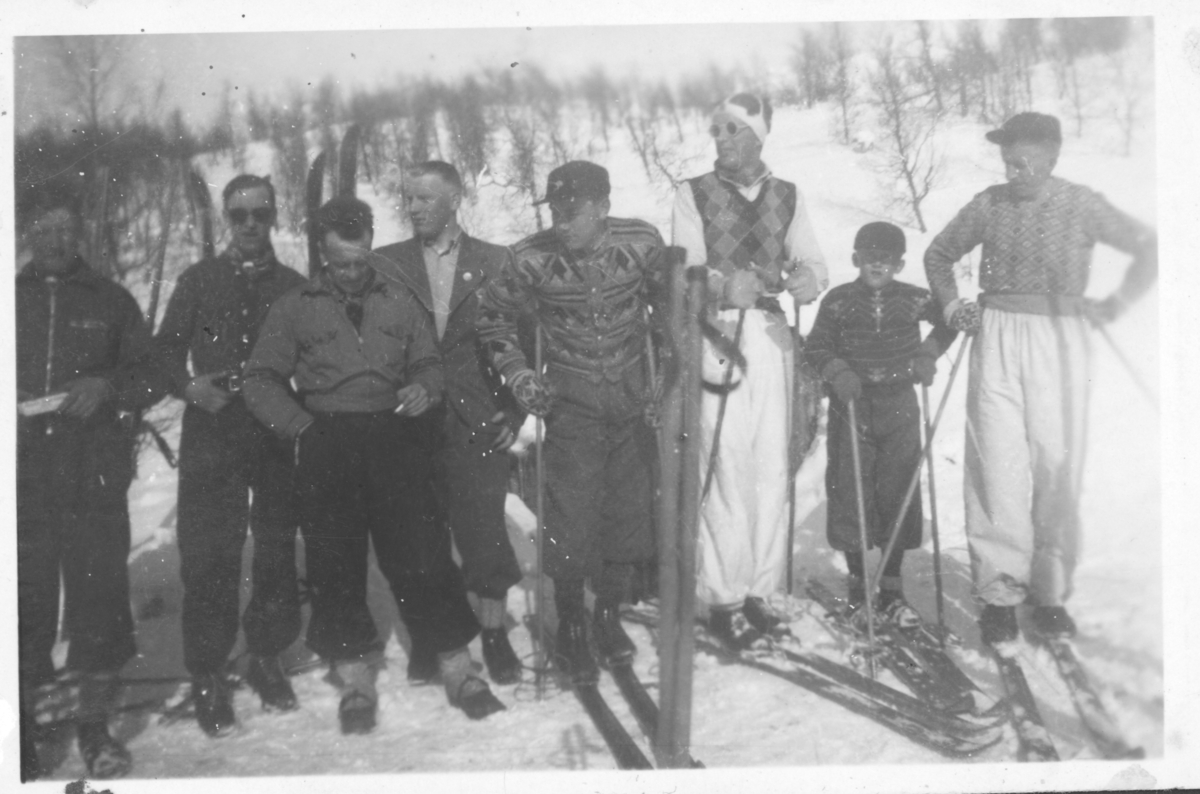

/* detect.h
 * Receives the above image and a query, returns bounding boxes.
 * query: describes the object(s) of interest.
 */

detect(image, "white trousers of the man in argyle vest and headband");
[696,309,793,607]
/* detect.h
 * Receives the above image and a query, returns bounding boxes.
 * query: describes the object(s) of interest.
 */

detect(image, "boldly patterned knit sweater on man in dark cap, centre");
[476,217,667,383]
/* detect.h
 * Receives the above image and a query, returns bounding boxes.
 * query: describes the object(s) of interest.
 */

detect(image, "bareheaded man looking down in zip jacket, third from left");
[245,197,504,733]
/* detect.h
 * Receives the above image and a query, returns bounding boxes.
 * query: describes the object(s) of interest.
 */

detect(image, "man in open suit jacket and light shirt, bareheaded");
[376,161,523,684]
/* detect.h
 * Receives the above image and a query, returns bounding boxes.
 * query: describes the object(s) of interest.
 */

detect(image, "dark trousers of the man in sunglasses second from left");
[178,399,300,675]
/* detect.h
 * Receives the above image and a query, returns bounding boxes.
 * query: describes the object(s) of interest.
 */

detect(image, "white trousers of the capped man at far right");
[964,308,1090,606]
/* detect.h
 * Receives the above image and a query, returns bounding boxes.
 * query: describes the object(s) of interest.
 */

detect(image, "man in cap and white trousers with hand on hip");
[925,113,1158,644]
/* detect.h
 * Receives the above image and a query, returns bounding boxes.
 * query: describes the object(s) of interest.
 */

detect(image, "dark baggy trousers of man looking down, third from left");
[296,411,479,661]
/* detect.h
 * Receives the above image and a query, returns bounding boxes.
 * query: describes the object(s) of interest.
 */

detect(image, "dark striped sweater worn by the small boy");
[804,278,955,387]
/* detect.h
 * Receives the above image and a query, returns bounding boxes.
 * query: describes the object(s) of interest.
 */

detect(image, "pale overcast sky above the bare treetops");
[16,24,835,126]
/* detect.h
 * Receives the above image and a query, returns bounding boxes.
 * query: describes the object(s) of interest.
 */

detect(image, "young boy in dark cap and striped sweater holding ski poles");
[805,222,955,622]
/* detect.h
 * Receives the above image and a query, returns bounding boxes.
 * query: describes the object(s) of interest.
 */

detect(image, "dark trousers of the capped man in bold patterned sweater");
[544,366,658,595]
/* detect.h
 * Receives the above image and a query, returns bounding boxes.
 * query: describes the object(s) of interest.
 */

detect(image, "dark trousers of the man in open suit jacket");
[430,404,521,598]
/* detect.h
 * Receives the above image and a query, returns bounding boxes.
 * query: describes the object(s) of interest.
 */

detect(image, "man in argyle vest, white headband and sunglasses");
[672,94,828,649]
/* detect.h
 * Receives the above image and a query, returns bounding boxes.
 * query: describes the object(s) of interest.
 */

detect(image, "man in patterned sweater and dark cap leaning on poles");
[476,161,667,684]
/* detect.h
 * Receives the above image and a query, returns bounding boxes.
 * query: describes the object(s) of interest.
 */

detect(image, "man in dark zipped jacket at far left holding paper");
[16,198,166,780]
